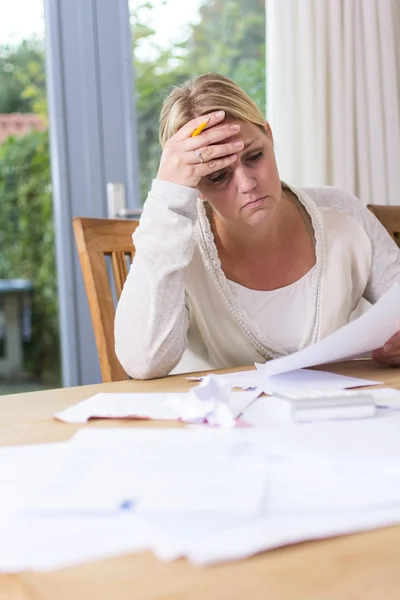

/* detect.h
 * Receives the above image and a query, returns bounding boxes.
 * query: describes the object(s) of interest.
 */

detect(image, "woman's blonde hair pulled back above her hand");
[160,73,264,148]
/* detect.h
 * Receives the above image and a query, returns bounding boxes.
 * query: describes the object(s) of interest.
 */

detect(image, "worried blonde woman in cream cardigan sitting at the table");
[115,73,400,379]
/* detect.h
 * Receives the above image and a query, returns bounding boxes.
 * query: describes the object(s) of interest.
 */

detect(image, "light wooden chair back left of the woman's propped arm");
[73,217,139,382]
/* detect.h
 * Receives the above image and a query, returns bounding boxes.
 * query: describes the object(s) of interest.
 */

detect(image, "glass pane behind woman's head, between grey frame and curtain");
[129,0,266,202]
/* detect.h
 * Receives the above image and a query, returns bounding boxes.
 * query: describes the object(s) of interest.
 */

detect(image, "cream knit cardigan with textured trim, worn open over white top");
[115,180,400,379]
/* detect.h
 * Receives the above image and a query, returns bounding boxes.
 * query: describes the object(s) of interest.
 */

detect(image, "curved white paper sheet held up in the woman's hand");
[256,283,400,375]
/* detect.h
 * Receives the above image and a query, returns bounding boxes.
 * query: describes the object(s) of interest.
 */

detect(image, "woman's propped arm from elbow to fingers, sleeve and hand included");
[115,111,244,379]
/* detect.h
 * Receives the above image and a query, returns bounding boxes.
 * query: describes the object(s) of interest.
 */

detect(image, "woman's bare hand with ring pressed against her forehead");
[157,111,243,188]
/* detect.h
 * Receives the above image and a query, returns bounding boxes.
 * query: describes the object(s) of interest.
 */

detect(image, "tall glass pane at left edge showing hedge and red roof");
[0,0,60,394]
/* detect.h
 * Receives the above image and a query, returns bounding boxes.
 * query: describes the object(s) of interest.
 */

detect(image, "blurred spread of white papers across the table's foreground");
[0,418,400,572]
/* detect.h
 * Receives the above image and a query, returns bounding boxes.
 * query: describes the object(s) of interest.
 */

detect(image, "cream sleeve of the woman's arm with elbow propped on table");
[115,179,198,379]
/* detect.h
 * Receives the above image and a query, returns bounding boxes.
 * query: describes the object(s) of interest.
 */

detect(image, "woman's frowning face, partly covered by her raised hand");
[198,121,281,225]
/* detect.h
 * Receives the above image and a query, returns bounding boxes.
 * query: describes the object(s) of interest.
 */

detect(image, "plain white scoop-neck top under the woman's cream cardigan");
[228,267,315,354]
